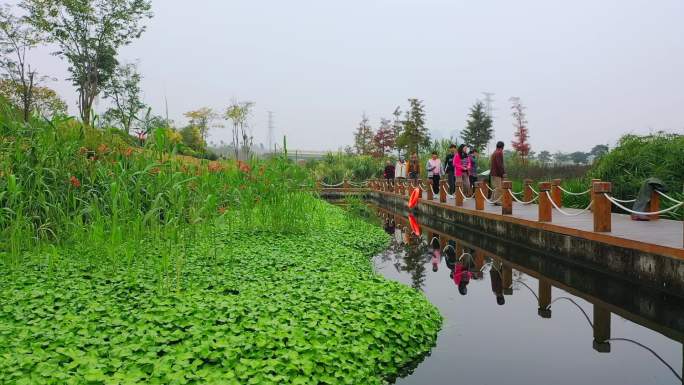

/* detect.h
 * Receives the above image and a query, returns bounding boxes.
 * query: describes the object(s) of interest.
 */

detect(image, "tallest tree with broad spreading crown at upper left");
[22,0,152,125]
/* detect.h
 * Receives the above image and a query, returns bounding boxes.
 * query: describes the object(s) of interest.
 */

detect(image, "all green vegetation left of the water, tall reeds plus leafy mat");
[0,100,441,384]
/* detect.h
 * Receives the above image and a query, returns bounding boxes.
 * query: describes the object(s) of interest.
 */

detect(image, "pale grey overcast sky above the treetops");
[25,0,684,152]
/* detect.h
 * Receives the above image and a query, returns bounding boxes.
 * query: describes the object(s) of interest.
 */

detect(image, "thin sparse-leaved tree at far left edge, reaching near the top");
[0,5,42,122]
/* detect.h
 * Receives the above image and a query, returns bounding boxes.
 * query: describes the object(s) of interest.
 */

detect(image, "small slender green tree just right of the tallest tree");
[104,64,145,133]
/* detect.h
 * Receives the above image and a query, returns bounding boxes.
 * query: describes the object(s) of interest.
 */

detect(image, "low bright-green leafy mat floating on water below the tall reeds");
[0,208,441,384]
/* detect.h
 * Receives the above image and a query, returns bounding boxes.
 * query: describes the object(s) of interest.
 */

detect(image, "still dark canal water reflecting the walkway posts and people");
[374,209,684,385]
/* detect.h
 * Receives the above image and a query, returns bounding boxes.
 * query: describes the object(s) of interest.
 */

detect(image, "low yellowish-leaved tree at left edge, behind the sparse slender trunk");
[0,79,67,118]
